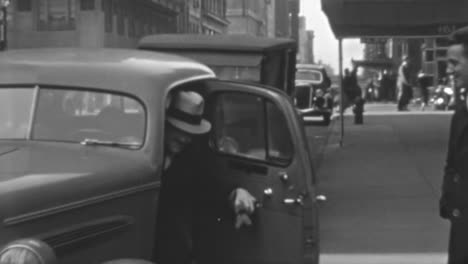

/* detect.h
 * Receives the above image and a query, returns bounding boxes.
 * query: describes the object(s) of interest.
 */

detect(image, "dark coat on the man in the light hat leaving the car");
[155,143,236,264]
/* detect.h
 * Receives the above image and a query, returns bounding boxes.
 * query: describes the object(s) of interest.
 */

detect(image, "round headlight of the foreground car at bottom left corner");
[0,239,57,264]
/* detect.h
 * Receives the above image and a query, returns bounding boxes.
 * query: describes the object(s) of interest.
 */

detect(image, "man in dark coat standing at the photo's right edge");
[440,27,468,264]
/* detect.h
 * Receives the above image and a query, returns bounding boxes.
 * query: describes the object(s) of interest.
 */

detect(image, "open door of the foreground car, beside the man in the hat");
[197,81,308,264]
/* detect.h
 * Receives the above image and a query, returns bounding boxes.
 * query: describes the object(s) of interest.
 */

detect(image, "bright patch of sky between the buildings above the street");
[300,0,364,73]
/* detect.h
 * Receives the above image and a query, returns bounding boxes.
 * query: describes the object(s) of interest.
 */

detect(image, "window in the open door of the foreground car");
[213,92,293,162]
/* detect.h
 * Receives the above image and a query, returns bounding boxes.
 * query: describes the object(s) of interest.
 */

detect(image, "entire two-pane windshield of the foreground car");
[0,87,146,148]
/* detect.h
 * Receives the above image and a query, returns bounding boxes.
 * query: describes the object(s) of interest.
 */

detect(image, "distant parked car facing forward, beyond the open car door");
[294,64,334,125]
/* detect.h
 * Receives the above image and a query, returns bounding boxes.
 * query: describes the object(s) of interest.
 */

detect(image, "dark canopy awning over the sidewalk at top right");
[322,0,468,38]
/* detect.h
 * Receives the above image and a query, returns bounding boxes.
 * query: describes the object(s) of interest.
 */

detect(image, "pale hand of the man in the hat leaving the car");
[230,188,257,229]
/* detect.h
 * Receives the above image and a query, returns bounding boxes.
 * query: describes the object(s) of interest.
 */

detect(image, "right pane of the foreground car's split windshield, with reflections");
[32,88,146,147]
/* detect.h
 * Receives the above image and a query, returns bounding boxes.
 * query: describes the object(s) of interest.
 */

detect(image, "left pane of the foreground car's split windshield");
[0,87,34,139]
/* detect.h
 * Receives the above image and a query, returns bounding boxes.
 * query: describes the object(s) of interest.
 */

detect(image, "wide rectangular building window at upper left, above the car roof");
[38,0,76,31]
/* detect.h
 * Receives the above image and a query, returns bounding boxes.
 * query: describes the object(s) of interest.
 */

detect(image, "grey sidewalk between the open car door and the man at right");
[314,104,451,264]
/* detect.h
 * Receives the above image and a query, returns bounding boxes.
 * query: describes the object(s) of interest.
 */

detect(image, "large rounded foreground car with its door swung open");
[0,49,319,264]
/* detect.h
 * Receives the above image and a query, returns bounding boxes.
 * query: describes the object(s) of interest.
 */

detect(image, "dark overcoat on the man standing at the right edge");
[440,105,468,264]
